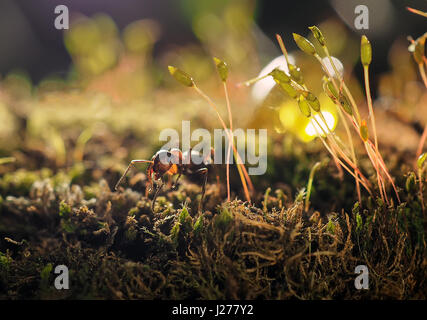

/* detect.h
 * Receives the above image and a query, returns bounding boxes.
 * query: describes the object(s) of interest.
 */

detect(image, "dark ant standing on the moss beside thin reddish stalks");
[114,148,214,212]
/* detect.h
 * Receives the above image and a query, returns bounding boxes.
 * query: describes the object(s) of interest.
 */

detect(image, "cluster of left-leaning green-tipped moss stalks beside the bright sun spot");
[242,26,406,203]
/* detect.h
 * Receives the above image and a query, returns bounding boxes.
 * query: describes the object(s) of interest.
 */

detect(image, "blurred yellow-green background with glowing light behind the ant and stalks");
[0,0,427,201]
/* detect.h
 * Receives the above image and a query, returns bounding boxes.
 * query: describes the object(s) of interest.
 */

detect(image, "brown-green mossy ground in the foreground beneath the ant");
[0,139,427,299]
